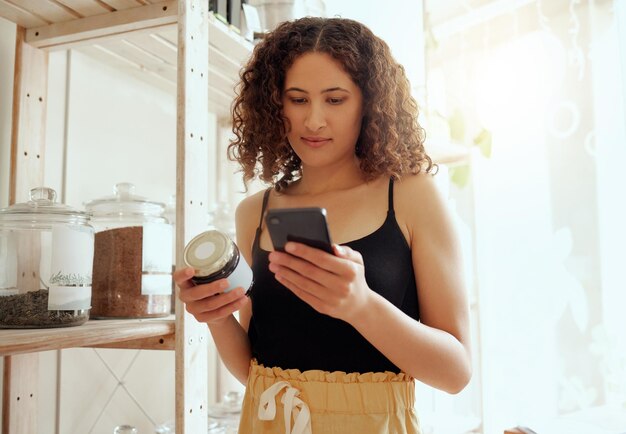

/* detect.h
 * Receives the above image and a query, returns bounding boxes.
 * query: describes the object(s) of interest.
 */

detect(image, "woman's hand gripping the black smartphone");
[269,242,373,324]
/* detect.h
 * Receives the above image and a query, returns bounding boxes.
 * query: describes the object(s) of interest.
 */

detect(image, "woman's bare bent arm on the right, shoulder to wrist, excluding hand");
[352,175,472,393]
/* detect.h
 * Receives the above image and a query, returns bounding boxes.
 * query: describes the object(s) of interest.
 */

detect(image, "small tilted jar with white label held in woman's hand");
[183,230,252,294]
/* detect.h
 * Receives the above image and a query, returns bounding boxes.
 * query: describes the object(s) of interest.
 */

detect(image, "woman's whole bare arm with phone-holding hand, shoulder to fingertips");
[270,175,472,393]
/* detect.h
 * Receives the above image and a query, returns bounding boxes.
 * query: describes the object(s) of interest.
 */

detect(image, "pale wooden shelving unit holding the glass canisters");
[0,0,252,434]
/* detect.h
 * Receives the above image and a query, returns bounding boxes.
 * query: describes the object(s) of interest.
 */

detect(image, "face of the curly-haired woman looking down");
[283,53,363,167]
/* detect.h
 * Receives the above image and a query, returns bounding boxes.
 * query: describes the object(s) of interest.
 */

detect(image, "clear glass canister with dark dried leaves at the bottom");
[0,187,94,328]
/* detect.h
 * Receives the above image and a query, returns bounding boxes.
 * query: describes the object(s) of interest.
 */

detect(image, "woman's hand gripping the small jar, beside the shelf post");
[173,268,249,324]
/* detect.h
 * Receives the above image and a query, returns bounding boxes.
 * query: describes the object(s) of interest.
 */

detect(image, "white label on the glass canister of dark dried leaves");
[44,226,94,310]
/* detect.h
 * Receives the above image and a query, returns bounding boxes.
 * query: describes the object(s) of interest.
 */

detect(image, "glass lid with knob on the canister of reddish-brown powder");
[85,182,165,217]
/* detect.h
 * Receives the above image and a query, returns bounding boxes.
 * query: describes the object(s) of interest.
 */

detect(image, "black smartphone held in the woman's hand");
[265,208,334,254]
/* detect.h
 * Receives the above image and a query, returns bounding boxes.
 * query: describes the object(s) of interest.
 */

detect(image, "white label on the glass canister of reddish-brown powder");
[141,223,173,295]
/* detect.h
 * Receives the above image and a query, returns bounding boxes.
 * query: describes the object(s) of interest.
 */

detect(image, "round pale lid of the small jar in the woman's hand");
[183,230,236,276]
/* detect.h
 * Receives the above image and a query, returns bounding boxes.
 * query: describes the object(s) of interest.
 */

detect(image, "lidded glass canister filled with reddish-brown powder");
[86,183,173,318]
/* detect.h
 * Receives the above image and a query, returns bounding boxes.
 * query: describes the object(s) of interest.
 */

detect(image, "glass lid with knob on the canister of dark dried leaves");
[0,187,89,224]
